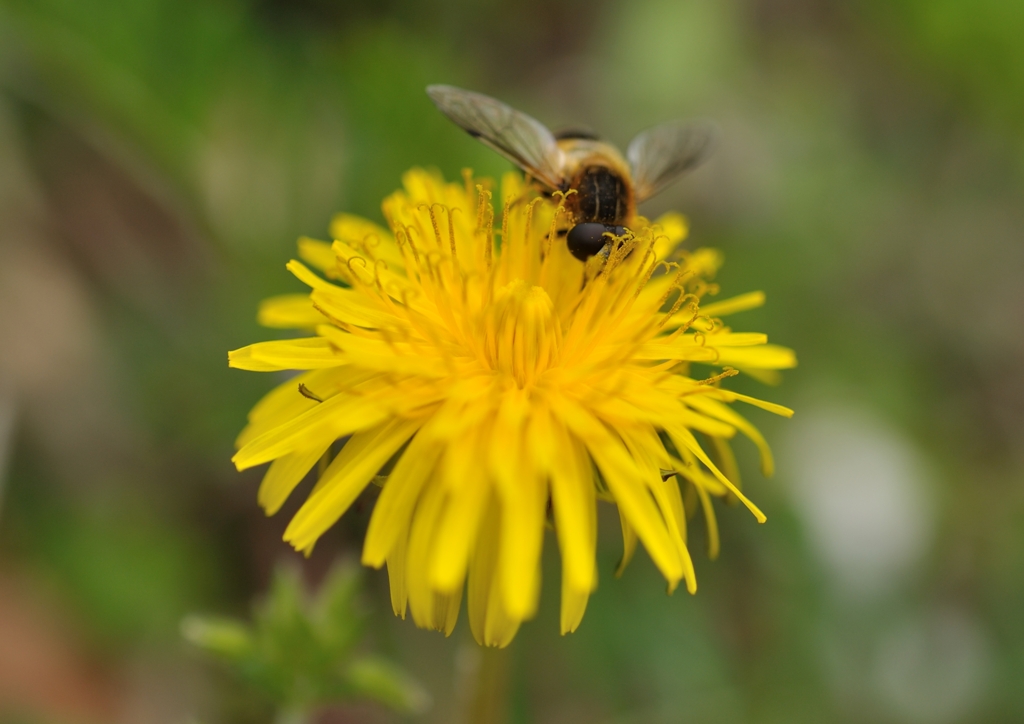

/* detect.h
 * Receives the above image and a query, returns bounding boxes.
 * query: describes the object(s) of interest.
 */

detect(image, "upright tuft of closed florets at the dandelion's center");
[485,280,562,387]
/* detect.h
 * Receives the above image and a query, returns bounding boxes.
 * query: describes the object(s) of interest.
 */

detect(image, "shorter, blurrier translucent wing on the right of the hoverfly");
[626,122,716,202]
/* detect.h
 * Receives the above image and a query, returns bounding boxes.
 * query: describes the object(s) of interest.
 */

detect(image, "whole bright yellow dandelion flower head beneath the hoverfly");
[229,170,796,646]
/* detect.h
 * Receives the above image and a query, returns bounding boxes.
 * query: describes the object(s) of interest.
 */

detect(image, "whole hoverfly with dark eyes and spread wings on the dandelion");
[427,85,715,261]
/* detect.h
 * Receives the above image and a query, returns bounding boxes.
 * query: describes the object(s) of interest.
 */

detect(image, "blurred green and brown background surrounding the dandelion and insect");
[0,0,1024,724]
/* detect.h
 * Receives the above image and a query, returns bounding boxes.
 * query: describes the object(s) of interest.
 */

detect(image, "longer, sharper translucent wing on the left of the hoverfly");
[427,85,563,190]
